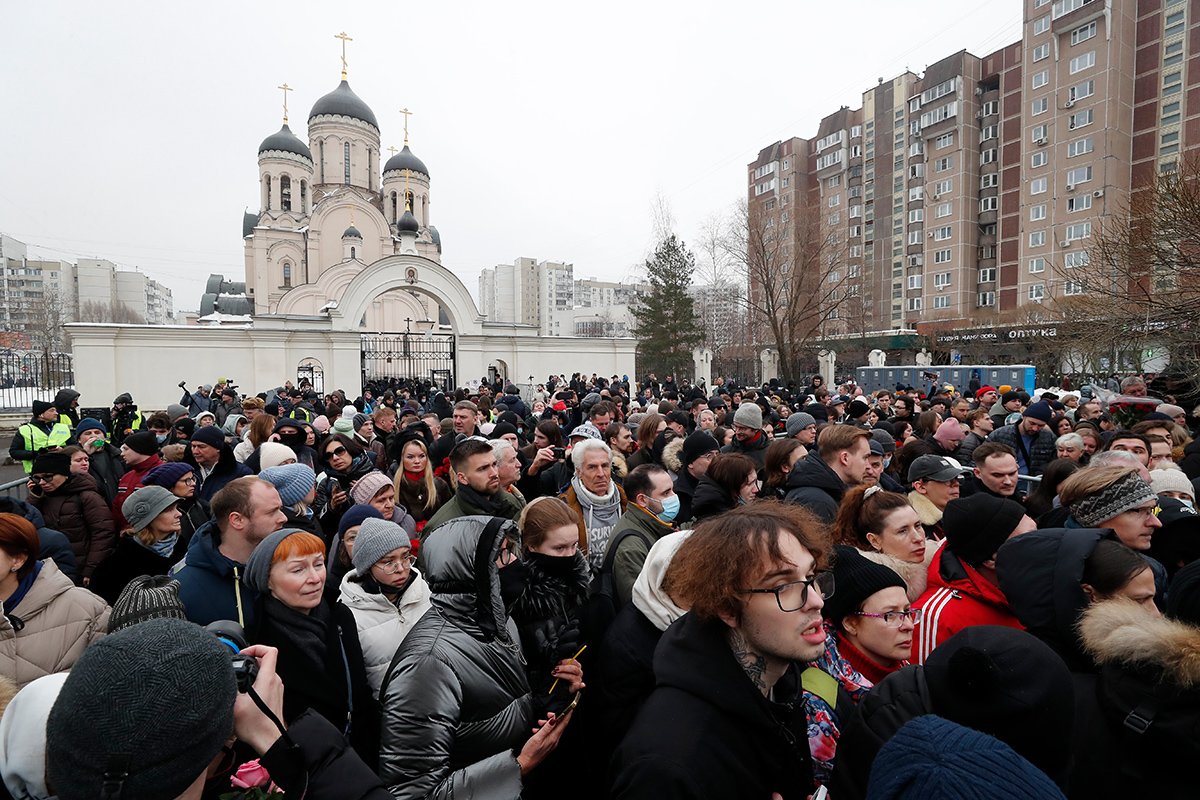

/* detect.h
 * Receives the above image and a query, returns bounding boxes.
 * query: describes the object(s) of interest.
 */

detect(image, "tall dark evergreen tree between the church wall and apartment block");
[634,234,704,380]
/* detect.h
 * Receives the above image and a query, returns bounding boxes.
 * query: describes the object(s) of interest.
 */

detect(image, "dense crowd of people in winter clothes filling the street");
[0,373,1200,800]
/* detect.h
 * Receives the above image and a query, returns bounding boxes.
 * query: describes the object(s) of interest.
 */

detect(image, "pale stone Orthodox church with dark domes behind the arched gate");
[242,73,448,331]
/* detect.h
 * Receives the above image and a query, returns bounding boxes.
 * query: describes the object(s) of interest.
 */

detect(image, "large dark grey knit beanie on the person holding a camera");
[46,619,238,800]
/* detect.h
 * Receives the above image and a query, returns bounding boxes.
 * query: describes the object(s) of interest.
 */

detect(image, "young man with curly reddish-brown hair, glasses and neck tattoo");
[608,504,833,800]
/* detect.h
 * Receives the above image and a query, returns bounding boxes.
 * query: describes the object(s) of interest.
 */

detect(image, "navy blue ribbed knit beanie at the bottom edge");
[866,715,1066,800]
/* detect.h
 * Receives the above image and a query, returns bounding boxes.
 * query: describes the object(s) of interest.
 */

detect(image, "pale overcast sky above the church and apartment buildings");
[0,0,1021,309]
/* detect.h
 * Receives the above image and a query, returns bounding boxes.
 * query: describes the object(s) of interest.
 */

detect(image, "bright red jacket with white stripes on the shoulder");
[912,547,1024,664]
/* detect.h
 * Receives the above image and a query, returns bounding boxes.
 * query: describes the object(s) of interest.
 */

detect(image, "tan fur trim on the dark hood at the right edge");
[1079,599,1200,688]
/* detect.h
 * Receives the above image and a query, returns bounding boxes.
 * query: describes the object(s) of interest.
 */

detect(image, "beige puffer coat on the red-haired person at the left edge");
[0,559,109,687]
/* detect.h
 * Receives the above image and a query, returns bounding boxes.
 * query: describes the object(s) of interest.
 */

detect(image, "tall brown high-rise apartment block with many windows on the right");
[748,0,1200,341]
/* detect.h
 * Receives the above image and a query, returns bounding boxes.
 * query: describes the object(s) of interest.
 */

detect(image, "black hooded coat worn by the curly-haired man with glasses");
[610,614,812,800]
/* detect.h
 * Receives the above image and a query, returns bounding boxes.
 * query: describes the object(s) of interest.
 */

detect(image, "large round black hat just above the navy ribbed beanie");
[925,623,1075,781]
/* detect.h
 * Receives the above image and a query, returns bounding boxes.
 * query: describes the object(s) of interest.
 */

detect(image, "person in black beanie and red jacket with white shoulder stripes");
[911,492,1037,664]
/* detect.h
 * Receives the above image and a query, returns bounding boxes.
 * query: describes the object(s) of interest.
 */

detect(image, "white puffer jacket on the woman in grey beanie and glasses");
[338,567,430,697]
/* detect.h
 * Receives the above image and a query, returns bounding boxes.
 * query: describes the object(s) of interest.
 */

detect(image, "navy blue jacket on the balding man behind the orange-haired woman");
[170,521,258,628]
